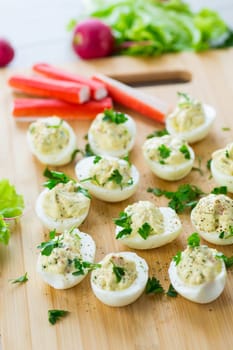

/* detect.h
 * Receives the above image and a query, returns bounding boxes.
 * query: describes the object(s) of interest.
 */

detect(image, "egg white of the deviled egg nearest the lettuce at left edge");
[35,188,91,232]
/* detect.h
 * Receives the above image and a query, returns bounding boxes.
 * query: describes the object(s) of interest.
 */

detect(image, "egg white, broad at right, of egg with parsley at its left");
[115,207,182,249]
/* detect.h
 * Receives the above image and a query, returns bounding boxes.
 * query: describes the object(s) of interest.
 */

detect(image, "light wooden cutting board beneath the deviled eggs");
[0,50,233,350]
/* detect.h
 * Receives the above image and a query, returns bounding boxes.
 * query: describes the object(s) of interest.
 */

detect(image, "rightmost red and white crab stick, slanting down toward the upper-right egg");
[93,74,168,123]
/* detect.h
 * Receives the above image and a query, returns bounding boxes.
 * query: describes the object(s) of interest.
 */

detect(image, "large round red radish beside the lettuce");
[72,18,114,59]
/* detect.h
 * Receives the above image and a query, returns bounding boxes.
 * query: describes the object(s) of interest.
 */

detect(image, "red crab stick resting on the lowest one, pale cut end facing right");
[8,75,90,103]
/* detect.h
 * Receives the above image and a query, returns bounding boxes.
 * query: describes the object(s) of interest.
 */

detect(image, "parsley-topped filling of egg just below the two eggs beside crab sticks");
[90,158,133,190]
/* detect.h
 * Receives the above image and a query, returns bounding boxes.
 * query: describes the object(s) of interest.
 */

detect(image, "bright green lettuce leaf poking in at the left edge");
[0,179,24,218]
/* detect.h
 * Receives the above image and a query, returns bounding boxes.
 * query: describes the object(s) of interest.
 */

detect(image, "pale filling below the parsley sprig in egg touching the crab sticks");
[89,114,132,151]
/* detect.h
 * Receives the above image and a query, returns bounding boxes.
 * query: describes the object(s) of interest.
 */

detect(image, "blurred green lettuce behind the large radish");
[72,0,233,56]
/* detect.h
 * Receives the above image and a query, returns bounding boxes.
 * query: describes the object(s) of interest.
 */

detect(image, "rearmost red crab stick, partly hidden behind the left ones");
[33,63,108,100]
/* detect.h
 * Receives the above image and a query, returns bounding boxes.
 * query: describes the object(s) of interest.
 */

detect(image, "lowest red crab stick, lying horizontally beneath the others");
[12,97,112,121]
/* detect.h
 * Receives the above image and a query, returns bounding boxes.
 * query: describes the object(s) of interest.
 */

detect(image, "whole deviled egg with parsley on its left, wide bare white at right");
[114,201,182,249]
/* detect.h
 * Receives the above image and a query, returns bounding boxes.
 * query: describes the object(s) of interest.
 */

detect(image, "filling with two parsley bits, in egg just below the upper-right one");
[143,135,191,165]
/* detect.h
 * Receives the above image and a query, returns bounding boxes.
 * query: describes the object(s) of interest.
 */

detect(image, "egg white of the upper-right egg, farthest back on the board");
[166,104,216,143]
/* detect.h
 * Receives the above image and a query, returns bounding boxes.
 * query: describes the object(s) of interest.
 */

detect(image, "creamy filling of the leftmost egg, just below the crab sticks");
[29,118,69,155]
